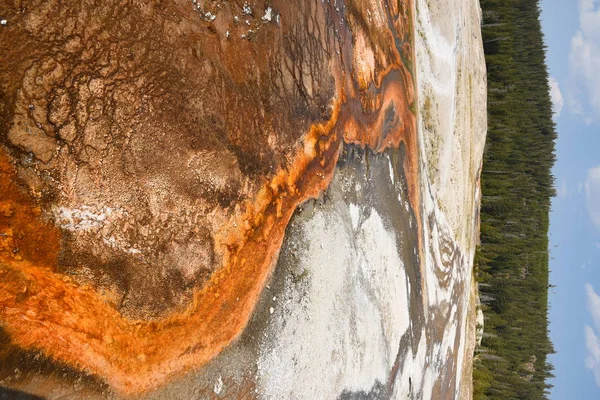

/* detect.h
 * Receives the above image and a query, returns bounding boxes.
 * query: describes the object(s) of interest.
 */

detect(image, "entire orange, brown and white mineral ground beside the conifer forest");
[0,0,486,399]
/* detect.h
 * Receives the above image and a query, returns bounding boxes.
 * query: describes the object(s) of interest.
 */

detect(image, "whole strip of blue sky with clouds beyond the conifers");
[541,0,600,399]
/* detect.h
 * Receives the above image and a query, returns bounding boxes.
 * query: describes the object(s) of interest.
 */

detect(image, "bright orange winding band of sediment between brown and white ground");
[0,1,421,393]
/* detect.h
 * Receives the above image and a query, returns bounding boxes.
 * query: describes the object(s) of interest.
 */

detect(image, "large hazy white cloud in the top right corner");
[567,0,600,124]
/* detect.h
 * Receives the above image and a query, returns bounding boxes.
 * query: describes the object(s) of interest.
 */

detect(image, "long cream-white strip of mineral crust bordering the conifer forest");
[415,0,487,399]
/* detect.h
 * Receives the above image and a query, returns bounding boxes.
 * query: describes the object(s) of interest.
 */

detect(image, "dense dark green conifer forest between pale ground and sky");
[474,0,556,399]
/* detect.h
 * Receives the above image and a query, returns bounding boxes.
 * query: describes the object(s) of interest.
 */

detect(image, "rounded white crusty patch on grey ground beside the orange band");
[258,196,409,399]
